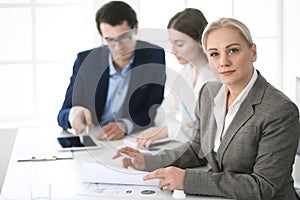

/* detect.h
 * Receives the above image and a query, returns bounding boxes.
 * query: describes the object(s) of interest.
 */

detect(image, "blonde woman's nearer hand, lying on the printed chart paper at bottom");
[143,167,185,191]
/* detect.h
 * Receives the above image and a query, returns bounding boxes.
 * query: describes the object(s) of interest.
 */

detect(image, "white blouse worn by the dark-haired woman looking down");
[155,63,216,141]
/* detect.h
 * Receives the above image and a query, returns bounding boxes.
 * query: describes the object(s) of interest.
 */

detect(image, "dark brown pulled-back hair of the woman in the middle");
[167,8,208,43]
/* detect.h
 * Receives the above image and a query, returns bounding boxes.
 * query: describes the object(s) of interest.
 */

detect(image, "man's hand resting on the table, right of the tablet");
[99,122,127,140]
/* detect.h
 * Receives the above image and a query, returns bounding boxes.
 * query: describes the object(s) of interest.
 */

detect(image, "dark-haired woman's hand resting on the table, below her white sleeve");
[136,126,168,148]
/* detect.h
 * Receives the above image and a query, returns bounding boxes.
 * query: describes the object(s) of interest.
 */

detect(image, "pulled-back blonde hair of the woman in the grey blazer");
[202,17,253,52]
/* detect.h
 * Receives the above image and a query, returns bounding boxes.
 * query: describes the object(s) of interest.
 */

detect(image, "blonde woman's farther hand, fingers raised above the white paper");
[112,147,146,170]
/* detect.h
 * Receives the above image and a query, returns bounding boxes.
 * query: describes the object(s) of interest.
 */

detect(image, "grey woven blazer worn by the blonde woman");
[145,72,300,200]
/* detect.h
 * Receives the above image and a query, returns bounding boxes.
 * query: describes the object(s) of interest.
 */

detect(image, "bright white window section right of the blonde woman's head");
[234,0,282,89]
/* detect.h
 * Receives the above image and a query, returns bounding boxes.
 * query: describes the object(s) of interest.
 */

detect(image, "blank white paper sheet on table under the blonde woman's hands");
[82,163,160,187]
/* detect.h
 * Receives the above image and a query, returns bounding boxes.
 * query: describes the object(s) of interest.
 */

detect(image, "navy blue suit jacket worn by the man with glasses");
[57,41,166,131]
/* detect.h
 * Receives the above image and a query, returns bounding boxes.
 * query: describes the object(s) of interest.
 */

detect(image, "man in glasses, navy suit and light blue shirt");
[58,1,166,140]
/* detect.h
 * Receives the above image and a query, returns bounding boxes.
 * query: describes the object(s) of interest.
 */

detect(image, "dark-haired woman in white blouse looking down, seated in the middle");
[136,8,215,148]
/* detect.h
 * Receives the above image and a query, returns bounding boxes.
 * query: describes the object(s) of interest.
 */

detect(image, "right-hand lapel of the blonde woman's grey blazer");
[217,71,266,170]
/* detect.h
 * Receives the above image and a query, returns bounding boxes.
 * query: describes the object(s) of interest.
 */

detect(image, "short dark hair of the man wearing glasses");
[96,1,137,35]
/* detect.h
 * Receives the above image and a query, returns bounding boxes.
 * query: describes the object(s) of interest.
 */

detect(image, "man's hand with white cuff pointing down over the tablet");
[69,106,94,134]
